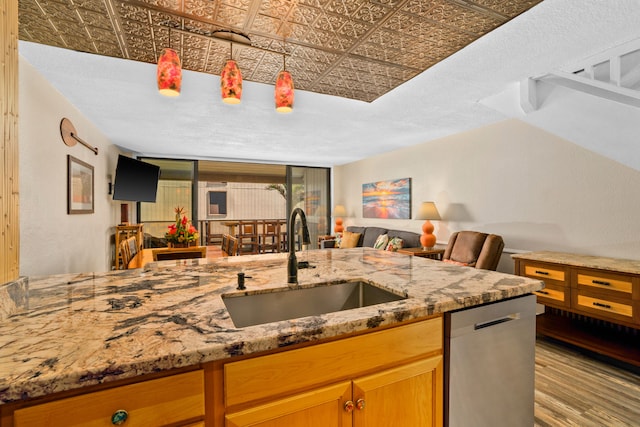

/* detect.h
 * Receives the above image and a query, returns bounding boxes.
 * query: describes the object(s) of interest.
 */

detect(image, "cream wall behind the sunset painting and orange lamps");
[334,119,640,272]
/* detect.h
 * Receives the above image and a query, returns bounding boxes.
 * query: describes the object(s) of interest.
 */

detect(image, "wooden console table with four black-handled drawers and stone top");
[512,251,640,366]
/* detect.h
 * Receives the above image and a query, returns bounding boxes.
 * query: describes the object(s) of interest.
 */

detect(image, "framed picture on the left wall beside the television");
[67,155,94,215]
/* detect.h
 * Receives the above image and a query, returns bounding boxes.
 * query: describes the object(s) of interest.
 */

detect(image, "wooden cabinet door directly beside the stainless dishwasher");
[353,356,443,427]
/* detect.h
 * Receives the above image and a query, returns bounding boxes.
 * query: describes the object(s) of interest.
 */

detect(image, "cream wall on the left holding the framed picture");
[18,57,120,276]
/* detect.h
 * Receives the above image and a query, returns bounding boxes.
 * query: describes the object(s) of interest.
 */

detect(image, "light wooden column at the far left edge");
[0,0,20,284]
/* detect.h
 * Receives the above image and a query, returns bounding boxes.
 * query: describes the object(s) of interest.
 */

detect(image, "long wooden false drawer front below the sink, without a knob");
[224,317,443,407]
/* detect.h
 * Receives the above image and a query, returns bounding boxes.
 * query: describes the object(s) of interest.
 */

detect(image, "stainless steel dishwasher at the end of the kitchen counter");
[445,295,536,427]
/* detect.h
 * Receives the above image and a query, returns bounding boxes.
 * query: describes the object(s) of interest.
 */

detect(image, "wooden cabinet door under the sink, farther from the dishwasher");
[225,381,352,427]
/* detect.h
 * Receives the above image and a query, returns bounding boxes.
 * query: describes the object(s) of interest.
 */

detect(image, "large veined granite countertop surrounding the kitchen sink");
[0,248,544,403]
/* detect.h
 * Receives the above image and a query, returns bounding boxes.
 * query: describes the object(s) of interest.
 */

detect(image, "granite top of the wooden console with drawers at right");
[511,251,640,274]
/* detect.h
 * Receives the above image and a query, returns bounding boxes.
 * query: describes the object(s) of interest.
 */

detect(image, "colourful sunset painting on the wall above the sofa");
[362,178,411,219]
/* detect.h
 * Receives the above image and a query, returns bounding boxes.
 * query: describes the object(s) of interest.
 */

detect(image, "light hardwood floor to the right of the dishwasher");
[535,338,640,427]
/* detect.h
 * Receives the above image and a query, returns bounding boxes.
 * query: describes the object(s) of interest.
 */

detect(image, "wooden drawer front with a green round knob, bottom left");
[14,370,204,427]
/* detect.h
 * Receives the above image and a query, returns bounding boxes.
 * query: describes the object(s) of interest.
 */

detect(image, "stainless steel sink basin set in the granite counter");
[222,280,406,328]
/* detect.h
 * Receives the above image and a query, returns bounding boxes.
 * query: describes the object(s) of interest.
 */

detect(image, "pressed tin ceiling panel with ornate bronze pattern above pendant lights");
[19,0,542,102]
